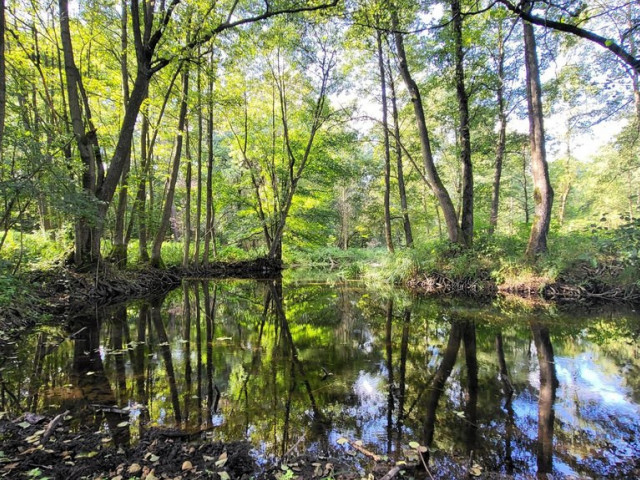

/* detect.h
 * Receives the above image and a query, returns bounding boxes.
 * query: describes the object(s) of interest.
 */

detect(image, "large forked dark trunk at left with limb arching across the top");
[59,0,337,265]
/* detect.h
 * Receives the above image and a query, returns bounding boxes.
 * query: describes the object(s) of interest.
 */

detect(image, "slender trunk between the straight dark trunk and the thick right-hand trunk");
[489,24,507,235]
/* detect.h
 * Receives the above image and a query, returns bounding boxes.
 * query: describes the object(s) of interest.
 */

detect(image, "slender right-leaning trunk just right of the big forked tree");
[150,64,189,267]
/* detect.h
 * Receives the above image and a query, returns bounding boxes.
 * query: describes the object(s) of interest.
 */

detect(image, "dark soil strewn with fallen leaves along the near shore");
[0,414,380,480]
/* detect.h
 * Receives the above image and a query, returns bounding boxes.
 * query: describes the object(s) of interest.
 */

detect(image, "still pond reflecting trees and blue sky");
[0,280,640,478]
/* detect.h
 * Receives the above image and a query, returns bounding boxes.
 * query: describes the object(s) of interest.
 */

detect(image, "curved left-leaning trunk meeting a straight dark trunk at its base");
[391,11,462,243]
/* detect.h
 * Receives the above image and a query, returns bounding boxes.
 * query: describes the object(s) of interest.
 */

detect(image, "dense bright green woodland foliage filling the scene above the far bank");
[0,0,640,288]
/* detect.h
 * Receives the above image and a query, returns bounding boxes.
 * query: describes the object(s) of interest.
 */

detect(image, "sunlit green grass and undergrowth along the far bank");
[0,220,640,307]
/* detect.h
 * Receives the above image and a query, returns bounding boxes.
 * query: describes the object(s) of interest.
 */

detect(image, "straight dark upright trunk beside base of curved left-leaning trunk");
[451,0,473,246]
